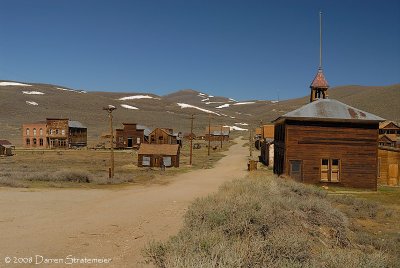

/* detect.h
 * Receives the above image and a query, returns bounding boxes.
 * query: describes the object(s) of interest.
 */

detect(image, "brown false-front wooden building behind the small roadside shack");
[115,123,149,149]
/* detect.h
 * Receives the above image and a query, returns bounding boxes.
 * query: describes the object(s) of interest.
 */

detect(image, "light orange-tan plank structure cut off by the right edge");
[378,146,400,186]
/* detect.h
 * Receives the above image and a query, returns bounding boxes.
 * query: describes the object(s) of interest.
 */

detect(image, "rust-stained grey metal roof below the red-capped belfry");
[275,99,385,122]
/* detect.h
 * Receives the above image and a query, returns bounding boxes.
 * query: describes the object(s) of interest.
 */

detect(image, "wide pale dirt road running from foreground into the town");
[0,139,247,267]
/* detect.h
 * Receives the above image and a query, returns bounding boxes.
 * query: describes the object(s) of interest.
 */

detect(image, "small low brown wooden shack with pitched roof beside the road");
[138,143,180,167]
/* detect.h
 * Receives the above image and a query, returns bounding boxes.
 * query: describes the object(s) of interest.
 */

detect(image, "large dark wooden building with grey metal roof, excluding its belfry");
[274,99,384,189]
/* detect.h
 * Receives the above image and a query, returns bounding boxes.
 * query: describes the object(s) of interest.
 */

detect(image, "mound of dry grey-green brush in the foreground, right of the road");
[144,173,398,267]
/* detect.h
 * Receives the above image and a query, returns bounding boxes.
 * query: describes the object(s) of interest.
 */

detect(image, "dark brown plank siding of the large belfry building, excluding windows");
[275,120,378,189]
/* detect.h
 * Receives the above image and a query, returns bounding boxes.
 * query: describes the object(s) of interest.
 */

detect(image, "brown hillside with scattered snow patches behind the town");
[0,81,400,145]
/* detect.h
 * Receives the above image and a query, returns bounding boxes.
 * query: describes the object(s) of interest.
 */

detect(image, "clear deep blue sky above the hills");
[0,0,400,100]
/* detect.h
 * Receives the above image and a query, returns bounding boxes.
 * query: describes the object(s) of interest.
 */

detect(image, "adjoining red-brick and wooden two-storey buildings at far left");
[22,118,87,149]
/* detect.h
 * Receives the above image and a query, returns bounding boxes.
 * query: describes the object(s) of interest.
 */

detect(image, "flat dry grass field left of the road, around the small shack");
[0,141,233,187]
